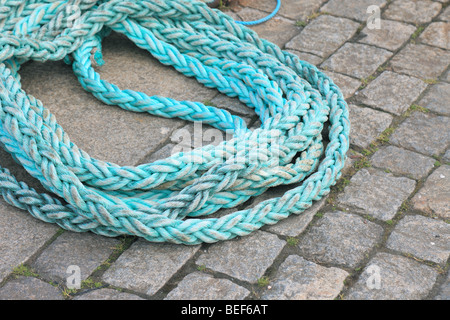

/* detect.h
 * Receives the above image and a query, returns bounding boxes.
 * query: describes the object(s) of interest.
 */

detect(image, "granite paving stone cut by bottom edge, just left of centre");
[164,272,250,300]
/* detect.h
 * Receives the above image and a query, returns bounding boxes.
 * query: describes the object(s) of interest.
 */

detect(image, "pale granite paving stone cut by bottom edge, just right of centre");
[261,255,348,300]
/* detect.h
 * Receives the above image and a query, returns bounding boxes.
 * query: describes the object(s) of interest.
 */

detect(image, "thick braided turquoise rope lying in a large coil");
[0,0,349,245]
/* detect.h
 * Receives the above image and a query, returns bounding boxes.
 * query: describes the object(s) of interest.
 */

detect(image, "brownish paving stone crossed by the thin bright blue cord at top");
[237,8,301,48]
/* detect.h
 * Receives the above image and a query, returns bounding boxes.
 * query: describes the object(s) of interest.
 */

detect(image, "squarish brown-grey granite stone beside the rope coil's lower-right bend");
[337,168,416,221]
